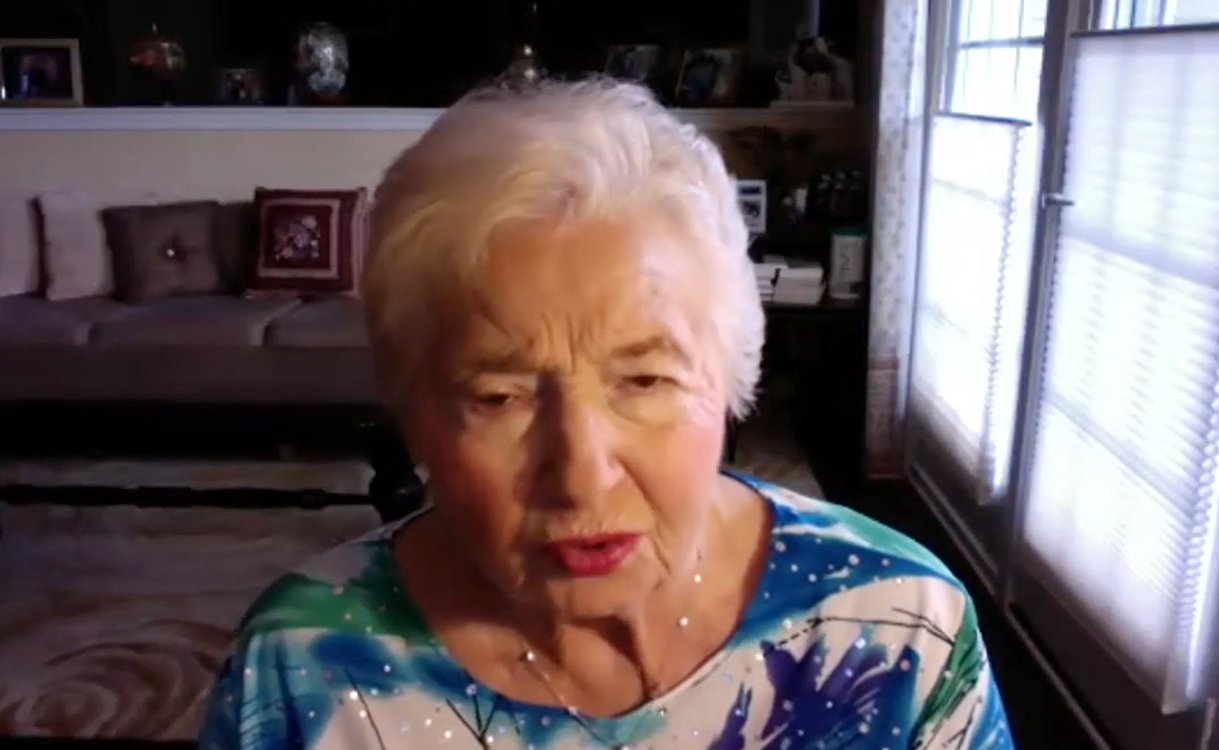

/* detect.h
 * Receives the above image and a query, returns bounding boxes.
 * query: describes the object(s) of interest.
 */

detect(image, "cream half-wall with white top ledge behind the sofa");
[0,104,868,205]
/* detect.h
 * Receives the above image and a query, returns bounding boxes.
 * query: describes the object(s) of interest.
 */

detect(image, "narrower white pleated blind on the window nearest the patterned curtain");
[908,113,1034,504]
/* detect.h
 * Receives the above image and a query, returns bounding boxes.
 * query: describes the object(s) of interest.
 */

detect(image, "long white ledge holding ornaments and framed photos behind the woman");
[0,101,857,130]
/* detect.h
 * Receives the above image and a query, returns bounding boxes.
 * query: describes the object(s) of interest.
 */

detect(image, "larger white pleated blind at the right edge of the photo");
[1024,30,1219,712]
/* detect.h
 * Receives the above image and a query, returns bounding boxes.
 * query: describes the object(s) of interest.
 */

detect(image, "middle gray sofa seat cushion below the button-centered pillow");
[90,295,300,346]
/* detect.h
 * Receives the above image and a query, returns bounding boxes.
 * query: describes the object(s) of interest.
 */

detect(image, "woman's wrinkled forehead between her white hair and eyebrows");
[434,218,712,367]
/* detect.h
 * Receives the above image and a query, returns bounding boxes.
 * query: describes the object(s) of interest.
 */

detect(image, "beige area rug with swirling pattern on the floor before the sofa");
[0,433,819,739]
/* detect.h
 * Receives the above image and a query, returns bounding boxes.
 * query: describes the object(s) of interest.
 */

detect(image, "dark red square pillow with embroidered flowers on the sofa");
[247,188,368,295]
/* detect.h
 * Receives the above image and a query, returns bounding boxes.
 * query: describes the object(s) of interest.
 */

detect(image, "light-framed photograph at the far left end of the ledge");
[0,39,84,107]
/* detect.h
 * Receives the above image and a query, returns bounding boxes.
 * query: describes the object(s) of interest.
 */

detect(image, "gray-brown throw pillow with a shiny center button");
[101,201,223,302]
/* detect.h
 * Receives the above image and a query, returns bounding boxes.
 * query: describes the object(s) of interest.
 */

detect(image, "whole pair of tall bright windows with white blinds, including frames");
[906,0,1219,750]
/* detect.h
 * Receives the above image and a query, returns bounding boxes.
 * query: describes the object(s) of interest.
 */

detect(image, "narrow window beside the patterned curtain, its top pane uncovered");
[906,0,1045,584]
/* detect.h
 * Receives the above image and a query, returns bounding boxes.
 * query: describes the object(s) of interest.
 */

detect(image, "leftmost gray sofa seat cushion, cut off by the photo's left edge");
[0,296,127,345]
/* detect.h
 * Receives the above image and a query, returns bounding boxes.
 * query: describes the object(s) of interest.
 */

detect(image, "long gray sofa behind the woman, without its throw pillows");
[0,197,377,406]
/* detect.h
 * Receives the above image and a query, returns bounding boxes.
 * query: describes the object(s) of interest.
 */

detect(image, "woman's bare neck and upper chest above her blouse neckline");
[399,478,768,716]
